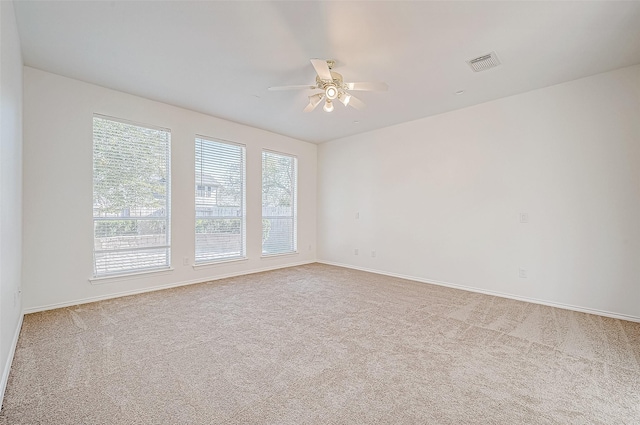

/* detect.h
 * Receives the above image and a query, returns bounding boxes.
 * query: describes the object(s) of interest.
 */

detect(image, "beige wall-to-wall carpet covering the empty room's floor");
[0,264,640,425]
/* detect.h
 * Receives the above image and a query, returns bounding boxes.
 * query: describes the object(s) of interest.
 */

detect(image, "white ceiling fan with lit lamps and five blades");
[269,59,389,112]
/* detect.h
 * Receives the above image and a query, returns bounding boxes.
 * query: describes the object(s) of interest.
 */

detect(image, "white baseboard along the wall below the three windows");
[24,260,316,314]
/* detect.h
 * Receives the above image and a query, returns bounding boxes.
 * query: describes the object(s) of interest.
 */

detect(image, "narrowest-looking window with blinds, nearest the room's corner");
[262,151,298,255]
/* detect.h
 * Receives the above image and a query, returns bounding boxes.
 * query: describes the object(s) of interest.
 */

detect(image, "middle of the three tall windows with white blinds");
[195,137,246,264]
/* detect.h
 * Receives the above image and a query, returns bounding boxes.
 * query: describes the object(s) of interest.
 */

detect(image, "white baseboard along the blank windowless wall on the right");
[317,260,640,323]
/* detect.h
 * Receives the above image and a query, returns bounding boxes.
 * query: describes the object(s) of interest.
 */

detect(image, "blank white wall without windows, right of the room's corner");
[318,66,640,319]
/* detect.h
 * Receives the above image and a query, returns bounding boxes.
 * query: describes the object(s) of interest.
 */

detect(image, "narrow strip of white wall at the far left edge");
[0,1,22,400]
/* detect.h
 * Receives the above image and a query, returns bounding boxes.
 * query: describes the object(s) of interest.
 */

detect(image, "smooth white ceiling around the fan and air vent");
[15,1,640,143]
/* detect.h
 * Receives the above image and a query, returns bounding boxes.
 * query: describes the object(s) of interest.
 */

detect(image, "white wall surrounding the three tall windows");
[23,67,317,312]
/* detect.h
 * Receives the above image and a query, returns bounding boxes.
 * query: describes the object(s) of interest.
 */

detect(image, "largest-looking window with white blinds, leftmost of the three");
[93,115,171,277]
